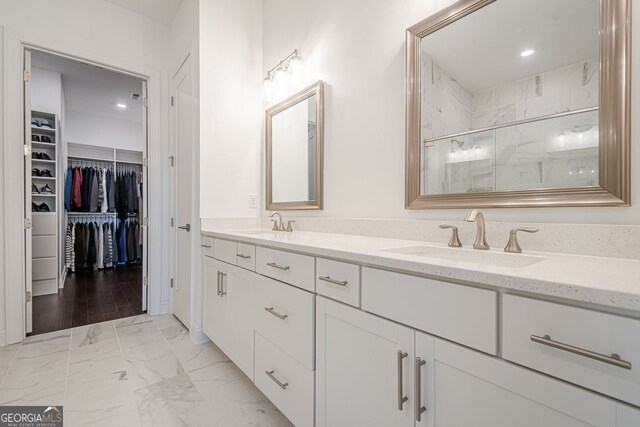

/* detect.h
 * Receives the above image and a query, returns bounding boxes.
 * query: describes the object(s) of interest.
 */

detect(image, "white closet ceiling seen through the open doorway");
[31,52,142,123]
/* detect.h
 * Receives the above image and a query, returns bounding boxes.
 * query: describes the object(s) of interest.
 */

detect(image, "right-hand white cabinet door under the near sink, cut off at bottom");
[416,333,617,427]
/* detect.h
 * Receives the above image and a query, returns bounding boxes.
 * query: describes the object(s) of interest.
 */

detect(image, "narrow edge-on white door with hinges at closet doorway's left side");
[23,49,33,334]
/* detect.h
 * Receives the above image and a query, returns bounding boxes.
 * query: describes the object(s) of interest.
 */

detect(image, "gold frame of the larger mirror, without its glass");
[405,0,631,209]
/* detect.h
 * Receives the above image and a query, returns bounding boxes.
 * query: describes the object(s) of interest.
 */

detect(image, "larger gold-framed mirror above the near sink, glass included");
[405,0,631,209]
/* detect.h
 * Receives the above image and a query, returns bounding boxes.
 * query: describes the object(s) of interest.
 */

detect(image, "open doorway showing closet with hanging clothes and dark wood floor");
[24,49,148,335]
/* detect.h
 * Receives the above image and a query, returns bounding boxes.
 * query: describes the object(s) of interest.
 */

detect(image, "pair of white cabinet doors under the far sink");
[203,257,257,379]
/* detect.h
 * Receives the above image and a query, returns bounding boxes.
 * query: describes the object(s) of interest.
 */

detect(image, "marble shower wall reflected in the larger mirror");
[421,53,599,195]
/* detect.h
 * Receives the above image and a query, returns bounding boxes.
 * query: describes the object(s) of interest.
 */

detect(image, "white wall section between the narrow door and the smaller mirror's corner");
[200,0,263,217]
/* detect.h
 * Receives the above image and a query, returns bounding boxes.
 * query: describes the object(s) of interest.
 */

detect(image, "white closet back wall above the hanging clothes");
[65,109,144,151]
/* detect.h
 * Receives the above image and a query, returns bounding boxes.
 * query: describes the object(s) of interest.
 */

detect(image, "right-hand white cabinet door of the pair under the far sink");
[221,264,257,379]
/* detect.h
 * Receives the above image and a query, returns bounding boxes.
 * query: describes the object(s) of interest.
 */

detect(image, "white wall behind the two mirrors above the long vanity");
[262,0,640,224]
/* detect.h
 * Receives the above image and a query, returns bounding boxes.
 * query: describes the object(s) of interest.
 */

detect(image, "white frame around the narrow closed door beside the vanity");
[167,43,208,343]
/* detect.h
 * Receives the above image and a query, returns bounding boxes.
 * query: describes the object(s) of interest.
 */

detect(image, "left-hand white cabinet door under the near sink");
[316,297,414,427]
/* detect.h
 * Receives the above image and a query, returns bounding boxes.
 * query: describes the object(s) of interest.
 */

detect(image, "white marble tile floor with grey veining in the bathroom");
[0,314,292,427]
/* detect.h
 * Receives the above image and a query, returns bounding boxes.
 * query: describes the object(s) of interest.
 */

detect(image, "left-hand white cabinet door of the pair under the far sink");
[202,256,225,348]
